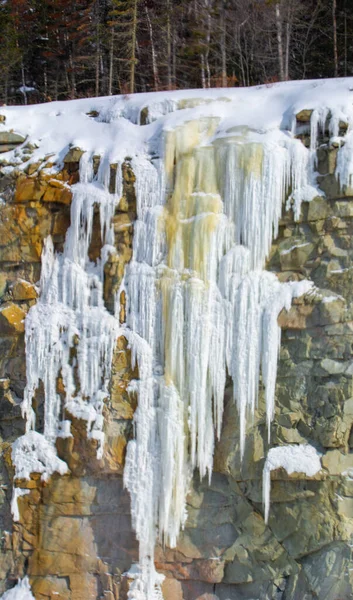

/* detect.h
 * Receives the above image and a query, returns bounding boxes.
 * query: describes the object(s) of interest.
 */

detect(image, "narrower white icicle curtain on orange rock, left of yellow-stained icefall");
[23,154,121,457]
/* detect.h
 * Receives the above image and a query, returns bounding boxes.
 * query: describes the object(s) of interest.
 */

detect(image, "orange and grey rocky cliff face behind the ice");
[0,89,353,600]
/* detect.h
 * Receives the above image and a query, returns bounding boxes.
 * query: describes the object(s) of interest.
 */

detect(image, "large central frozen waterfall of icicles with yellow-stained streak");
[124,117,316,600]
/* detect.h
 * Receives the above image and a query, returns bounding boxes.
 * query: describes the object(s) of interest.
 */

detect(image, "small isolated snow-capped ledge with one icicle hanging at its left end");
[262,444,321,523]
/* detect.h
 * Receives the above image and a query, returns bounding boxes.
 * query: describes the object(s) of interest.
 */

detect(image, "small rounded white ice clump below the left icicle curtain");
[12,431,68,482]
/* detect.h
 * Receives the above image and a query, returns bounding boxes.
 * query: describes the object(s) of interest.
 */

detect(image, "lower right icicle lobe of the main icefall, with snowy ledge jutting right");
[226,271,312,457]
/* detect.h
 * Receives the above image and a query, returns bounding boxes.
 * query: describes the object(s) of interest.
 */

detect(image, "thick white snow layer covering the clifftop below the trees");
[0,78,353,171]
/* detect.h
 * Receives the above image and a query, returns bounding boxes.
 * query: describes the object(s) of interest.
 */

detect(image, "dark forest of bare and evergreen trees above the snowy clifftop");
[0,0,353,104]
